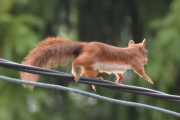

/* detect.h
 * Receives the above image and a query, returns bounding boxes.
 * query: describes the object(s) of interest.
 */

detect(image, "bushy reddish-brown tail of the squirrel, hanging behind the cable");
[20,38,83,89]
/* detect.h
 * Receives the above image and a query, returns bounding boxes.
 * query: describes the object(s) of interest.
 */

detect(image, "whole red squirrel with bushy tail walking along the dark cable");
[20,37,153,90]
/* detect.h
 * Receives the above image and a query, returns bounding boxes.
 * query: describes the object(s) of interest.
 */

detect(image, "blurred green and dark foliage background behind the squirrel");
[0,0,180,120]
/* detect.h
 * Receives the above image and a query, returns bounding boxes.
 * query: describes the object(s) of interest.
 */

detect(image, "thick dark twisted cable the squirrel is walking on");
[0,59,180,103]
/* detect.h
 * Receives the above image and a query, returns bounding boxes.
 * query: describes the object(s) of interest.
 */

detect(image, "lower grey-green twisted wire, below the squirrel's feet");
[0,76,180,117]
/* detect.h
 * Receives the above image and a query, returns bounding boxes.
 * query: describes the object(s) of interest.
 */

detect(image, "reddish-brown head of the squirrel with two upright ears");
[128,38,148,64]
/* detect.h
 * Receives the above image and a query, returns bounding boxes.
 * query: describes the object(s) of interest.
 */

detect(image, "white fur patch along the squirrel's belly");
[92,62,131,73]
